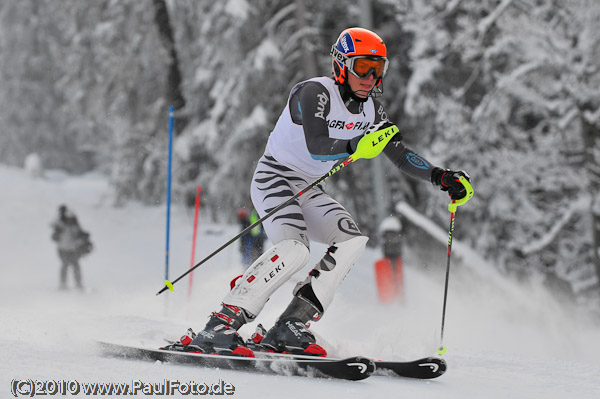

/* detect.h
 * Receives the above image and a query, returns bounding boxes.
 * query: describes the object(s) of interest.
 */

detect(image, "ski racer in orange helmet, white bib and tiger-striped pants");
[180,28,468,356]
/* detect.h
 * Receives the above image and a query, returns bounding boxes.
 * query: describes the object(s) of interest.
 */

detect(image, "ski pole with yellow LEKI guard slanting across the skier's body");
[156,125,398,295]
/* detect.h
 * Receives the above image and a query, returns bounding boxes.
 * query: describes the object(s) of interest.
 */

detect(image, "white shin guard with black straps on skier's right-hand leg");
[294,236,369,312]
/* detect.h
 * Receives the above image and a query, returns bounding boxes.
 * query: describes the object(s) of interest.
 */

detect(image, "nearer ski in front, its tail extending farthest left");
[98,342,375,381]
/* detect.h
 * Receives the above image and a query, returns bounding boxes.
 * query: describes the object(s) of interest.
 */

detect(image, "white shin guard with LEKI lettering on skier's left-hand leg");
[223,240,309,316]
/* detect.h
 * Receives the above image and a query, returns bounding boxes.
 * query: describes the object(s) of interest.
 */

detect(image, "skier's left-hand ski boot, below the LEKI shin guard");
[188,304,254,357]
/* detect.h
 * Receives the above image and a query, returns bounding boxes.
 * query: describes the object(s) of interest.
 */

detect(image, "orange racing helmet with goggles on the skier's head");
[330,28,388,95]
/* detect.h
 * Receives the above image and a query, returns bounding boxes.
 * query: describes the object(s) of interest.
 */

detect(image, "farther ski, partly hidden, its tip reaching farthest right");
[244,345,448,380]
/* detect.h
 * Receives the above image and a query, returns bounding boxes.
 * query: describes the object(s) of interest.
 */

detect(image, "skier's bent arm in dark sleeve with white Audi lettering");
[289,82,350,161]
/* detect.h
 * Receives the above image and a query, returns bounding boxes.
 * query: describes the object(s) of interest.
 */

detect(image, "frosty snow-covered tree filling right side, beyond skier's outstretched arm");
[396,0,600,308]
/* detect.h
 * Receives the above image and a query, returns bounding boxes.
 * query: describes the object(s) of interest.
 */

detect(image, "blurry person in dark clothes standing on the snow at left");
[52,205,93,289]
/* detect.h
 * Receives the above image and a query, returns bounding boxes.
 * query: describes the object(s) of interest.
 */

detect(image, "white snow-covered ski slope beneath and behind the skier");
[0,166,600,399]
